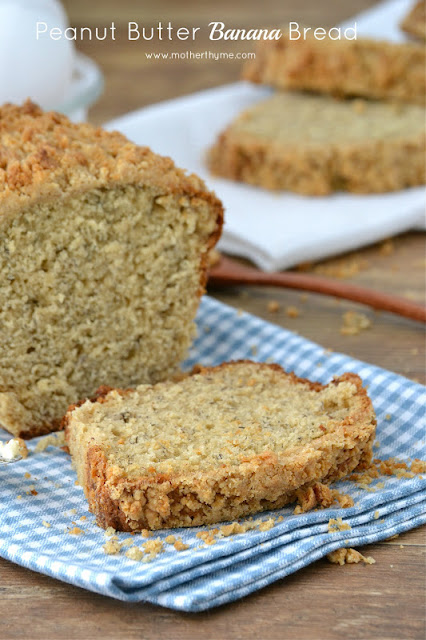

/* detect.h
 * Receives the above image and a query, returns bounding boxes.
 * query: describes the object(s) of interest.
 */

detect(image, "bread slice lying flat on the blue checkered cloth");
[64,361,376,531]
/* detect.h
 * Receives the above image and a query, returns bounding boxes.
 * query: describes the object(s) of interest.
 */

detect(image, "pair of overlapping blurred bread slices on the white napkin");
[208,33,426,195]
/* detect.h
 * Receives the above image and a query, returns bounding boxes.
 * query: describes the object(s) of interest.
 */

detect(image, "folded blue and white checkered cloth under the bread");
[0,297,426,611]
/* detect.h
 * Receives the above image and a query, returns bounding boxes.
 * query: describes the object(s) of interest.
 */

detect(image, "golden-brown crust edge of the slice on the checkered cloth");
[64,361,376,531]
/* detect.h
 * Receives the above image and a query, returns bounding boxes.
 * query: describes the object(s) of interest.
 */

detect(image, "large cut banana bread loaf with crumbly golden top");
[0,102,222,437]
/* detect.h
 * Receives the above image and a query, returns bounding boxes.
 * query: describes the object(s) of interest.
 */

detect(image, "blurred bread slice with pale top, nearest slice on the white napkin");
[208,92,425,195]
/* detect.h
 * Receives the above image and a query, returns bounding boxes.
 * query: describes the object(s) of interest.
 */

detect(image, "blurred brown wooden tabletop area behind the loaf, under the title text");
[63,0,375,123]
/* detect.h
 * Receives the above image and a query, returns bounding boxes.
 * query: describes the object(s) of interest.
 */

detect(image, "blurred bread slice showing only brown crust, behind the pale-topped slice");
[243,33,426,104]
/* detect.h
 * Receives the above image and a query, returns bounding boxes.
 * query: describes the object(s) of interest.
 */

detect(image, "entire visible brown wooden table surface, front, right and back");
[0,0,425,640]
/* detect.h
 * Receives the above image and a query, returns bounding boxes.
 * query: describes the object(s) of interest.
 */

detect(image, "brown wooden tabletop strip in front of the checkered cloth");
[0,532,425,640]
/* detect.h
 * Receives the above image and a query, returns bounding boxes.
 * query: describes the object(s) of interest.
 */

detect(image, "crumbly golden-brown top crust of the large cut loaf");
[0,100,222,221]
